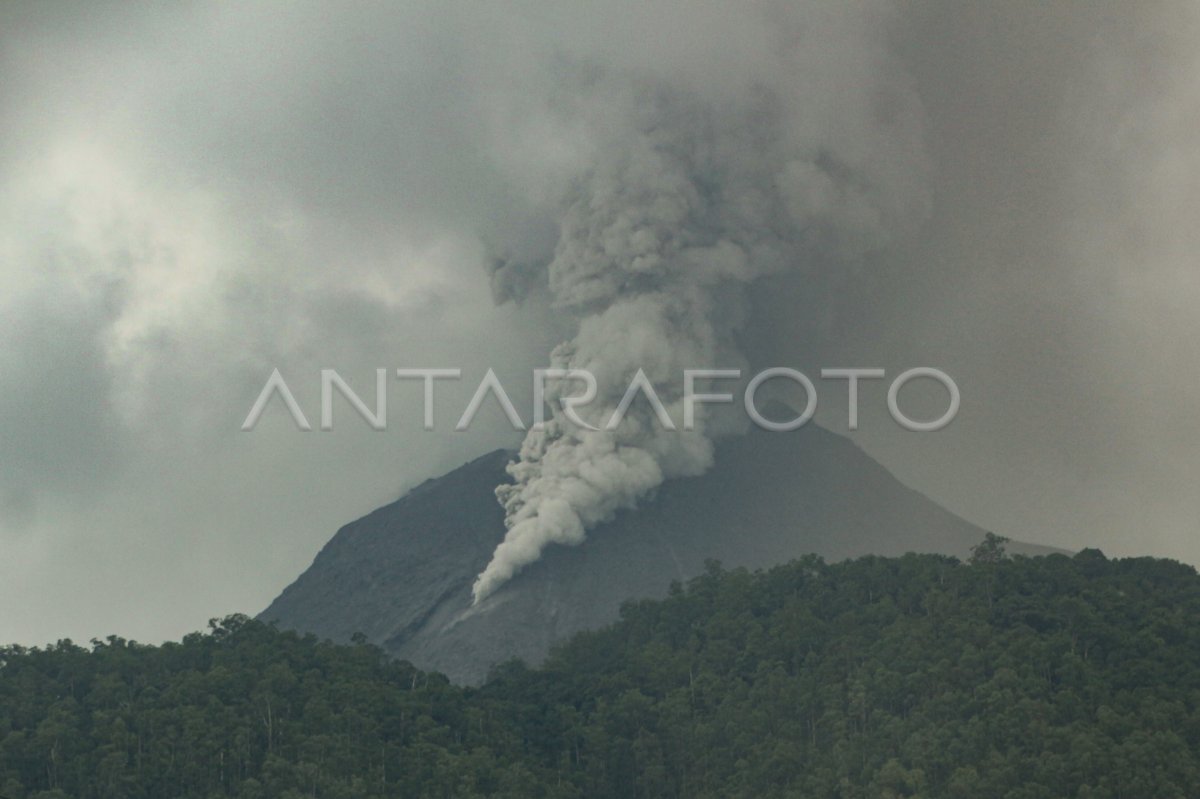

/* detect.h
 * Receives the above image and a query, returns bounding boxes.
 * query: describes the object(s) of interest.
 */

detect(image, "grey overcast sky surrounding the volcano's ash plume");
[0,0,1200,644]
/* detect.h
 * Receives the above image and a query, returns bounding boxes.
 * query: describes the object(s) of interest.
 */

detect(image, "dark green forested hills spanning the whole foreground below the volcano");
[0,540,1200,799]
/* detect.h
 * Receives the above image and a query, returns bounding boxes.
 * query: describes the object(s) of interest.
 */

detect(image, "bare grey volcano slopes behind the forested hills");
[260,425,1051,683]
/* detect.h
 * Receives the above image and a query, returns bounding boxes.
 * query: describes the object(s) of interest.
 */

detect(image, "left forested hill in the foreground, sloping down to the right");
[0,615,577,799]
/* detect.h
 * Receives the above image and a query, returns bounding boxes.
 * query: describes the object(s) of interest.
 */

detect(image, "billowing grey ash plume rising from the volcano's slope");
[474,6,929,602]
